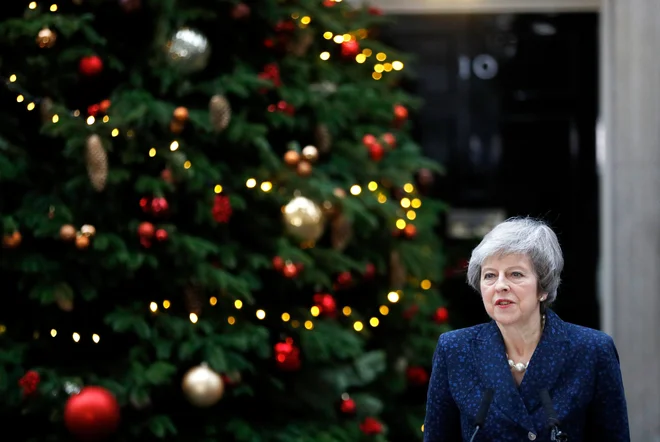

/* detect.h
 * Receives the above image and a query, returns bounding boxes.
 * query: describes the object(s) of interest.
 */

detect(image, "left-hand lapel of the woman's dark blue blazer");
[473,321,534,431]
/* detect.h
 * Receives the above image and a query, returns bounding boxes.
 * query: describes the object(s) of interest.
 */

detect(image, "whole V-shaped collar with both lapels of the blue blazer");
[473,310,569,431]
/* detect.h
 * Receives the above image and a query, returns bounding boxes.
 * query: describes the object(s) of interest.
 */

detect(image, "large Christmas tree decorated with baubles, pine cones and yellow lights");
[0,0,448,442]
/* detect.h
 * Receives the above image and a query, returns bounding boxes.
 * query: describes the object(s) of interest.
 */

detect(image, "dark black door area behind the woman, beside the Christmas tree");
[384,14,599,328]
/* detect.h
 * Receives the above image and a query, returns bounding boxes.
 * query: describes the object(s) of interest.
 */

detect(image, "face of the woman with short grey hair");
[481,254,547,325]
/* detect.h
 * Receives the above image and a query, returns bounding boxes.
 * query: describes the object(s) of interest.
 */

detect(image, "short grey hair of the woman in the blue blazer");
[467,217,564,310]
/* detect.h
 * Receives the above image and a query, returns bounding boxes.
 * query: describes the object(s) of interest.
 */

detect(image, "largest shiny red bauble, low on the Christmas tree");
[64,387,119,442]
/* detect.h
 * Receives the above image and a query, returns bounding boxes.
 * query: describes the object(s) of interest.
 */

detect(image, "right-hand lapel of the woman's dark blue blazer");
[520,310,569,414]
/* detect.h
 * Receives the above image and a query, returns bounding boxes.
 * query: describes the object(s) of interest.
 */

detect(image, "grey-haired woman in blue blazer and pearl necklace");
[424,218,630,442]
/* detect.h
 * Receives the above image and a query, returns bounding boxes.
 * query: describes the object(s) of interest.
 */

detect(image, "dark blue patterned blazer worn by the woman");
[424,310,630,442]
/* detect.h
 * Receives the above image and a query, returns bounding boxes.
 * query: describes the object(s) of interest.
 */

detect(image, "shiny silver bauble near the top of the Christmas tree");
[167,28,211,74]
